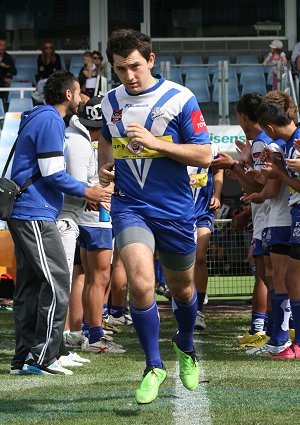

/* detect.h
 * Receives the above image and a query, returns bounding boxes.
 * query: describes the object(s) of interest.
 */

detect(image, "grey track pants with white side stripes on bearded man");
[8,219,70,368]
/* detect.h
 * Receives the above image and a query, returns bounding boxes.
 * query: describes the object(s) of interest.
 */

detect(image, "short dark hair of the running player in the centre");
[106,29,151,66]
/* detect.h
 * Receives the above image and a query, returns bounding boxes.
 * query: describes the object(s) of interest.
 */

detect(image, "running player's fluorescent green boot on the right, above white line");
[172,335,199,391]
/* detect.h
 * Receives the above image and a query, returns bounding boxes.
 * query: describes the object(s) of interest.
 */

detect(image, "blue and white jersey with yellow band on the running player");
[102,78,210,220]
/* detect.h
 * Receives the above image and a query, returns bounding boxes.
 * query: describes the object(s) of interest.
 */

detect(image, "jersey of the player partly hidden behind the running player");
[187,143,219,217]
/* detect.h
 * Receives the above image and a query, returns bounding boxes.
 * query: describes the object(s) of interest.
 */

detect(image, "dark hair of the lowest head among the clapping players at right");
[257,100,292,127]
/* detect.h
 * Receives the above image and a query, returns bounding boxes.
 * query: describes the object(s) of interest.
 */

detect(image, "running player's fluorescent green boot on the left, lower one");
[135,367,167,404]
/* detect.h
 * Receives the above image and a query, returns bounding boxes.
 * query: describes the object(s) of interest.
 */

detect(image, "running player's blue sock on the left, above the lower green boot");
[130,302,162,368]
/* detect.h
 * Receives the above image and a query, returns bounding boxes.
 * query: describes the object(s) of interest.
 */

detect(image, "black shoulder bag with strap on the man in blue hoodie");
[0,138,41,221]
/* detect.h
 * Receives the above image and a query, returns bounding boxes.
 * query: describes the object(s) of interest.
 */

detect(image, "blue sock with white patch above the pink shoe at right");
[271,292,291,345]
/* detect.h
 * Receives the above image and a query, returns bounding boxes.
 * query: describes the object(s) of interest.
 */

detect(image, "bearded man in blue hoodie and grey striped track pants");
[8,71,109,374]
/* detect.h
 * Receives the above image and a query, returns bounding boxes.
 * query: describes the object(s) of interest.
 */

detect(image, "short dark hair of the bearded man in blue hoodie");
[44,71,78,105]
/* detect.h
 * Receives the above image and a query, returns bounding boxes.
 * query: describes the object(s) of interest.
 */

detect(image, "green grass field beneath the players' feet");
[0,304,300,425]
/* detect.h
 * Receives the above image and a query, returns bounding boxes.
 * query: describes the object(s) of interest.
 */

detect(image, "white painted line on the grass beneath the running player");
[173,346,212,425]
